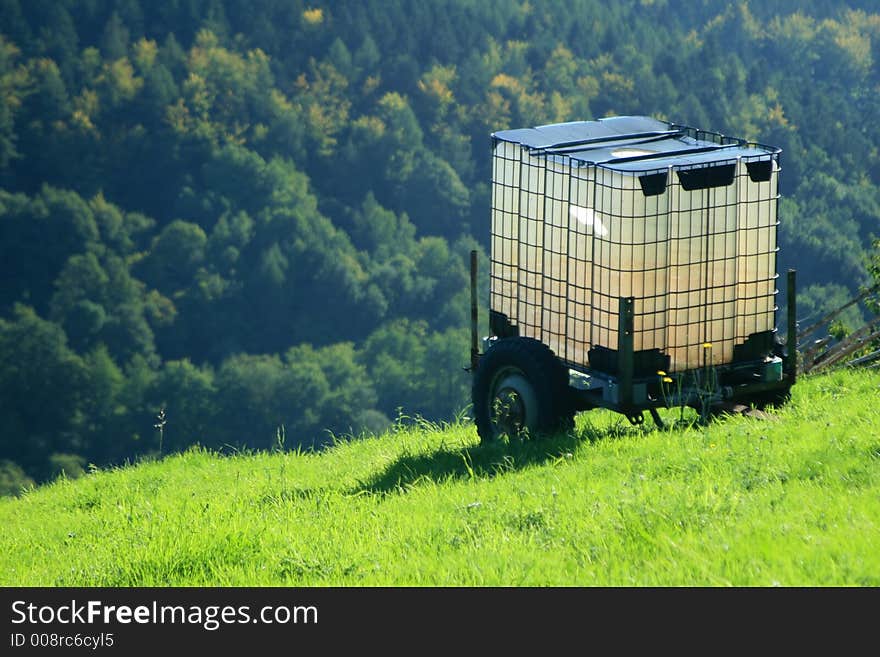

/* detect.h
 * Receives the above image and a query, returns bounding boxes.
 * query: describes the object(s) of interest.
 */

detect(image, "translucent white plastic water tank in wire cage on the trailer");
[490,116,780,371]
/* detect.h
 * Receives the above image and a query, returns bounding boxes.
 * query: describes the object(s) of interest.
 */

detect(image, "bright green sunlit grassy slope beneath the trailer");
[0,371,880,586]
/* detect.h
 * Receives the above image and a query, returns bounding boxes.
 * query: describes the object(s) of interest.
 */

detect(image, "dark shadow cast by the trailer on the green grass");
[350,421,642,495]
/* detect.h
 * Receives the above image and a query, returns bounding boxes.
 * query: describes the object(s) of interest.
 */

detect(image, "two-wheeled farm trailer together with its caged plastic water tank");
[470,116,797,441]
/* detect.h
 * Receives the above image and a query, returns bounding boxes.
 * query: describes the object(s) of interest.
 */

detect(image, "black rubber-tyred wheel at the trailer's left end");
[471,337,574,443]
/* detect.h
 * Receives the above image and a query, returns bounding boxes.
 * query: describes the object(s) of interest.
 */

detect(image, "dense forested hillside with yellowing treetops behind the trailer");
[0,0,880,491]
